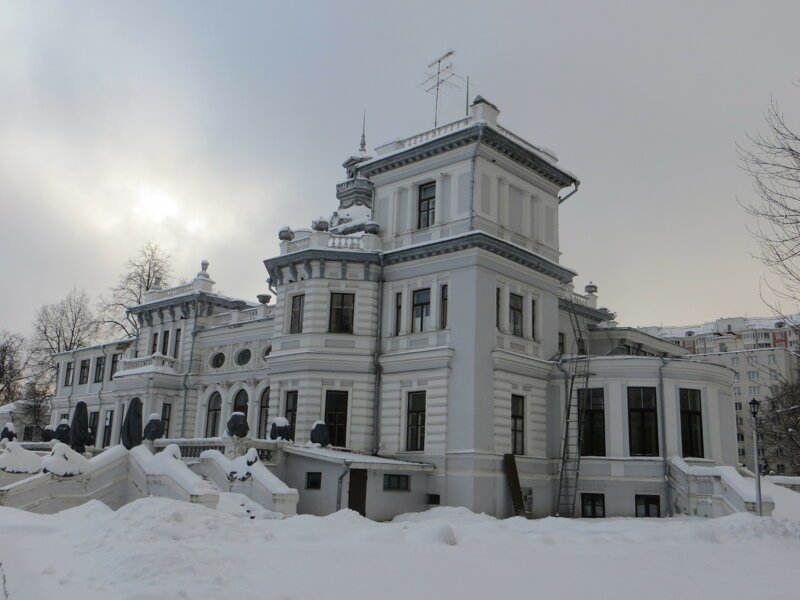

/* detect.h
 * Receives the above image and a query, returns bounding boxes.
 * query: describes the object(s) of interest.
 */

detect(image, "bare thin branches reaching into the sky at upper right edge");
[738,88,800,314]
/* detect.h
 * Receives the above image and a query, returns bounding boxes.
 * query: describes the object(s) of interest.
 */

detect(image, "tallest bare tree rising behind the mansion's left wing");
[98,242,172,337]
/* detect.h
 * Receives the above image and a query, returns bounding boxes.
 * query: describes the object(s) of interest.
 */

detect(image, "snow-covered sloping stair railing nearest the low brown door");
[191,448,299,517]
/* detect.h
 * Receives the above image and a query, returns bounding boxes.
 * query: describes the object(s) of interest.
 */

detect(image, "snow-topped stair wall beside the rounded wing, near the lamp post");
[669,456,775,517]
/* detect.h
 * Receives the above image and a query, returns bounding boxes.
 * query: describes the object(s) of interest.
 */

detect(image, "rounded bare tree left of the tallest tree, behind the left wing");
[32,289,97,384]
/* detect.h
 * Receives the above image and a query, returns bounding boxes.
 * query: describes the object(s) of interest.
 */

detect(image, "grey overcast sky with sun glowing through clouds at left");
[0,0,800,333]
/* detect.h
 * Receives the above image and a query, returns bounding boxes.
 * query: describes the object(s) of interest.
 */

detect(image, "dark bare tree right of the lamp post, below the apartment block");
[759,383,800,474]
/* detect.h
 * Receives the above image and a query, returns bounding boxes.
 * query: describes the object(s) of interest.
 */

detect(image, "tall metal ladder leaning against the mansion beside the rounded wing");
[556,305,590,517]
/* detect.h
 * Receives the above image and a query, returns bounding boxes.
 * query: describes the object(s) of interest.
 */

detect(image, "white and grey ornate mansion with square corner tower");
[47,97,744,519]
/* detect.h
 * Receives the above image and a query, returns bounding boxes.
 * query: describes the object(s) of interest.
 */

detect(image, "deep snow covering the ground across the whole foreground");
[0,492,800,600]
